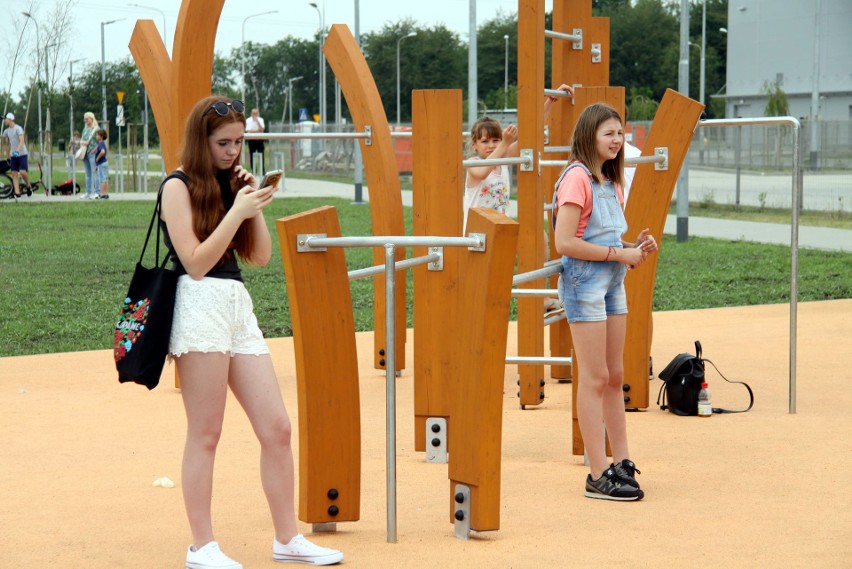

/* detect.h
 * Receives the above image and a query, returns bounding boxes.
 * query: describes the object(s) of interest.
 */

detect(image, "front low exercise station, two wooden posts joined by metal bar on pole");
[277,207,517,543]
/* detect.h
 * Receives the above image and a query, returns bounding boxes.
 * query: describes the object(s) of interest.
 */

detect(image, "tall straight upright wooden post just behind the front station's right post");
[412,90,462,452]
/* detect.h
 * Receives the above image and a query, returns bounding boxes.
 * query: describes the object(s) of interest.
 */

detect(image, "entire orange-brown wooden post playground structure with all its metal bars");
[131,0,820,541]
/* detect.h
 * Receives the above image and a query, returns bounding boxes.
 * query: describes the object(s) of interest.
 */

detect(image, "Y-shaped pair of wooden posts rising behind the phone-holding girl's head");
[129,0,225,171]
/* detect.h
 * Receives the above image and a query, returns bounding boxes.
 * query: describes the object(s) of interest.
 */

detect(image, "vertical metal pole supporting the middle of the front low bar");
[385,244,397,543]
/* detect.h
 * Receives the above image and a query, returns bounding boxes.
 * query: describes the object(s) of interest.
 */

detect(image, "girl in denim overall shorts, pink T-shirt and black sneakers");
[553,103,657,500]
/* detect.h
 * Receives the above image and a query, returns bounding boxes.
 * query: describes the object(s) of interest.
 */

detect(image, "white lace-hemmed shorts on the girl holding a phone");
[169,275,269,356]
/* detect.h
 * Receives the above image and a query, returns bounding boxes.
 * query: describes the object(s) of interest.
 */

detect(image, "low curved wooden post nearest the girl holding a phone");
[276,206,361,523]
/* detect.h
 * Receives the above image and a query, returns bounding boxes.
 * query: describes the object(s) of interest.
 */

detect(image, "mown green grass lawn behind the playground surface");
[0,198,852,357]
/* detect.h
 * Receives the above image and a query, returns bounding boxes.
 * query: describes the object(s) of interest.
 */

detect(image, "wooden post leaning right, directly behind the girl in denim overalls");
[624,89,704,408]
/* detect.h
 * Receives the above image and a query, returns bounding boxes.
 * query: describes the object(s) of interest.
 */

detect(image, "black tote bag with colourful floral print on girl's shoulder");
[113,178,178,389]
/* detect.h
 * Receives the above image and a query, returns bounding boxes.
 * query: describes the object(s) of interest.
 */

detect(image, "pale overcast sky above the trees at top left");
[0,0,540,94]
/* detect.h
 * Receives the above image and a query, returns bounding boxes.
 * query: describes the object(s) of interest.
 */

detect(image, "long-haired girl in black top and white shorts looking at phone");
[161,96,343,569]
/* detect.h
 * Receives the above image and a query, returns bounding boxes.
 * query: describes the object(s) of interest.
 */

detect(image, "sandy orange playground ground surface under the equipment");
[0,300,852,569]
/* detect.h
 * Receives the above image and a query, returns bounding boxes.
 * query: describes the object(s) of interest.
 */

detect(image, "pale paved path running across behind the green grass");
[5,175,852,251]
